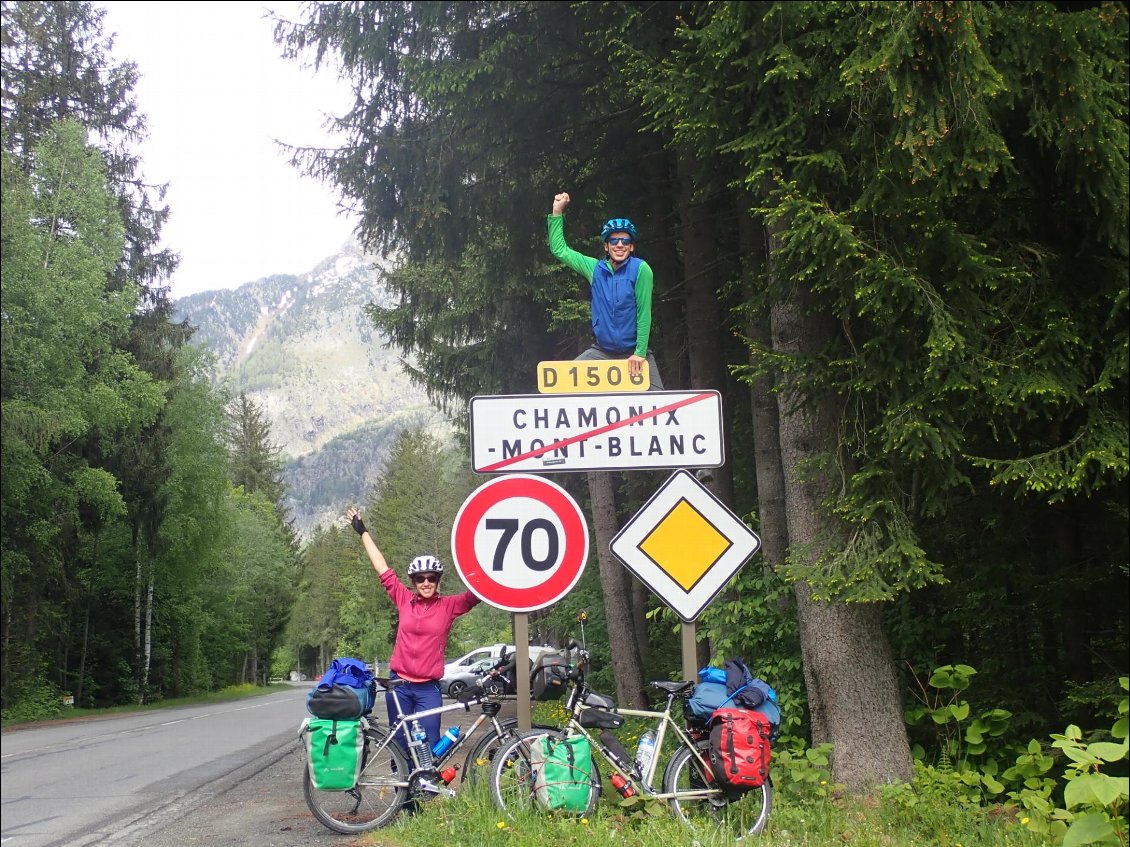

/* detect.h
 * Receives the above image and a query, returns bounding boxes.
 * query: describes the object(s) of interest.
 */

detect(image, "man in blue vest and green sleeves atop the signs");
[547,192,663,391]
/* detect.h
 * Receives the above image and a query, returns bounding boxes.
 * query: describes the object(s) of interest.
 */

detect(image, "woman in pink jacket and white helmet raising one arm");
[346,507,479,752]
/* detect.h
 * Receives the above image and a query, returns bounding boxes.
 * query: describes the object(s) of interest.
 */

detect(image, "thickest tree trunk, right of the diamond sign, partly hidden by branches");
[772,280,913,793]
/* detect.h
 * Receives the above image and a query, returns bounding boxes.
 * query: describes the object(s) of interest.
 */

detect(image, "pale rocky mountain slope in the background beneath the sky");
[175,245,451,535]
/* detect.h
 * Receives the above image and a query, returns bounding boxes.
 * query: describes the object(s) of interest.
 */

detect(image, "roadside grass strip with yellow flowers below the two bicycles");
[357,783,1054,847]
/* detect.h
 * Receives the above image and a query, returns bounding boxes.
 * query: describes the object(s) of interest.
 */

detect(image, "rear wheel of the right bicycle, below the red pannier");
[663,746,773,840]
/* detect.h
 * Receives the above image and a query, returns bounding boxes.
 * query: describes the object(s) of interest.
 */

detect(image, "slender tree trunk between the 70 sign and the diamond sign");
[588,472,646,709]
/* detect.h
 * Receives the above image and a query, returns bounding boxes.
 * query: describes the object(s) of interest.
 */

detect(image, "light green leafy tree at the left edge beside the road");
[0,121,165,704]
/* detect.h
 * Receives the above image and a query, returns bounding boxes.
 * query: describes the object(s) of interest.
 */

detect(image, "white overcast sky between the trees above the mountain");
[97,0,353,299]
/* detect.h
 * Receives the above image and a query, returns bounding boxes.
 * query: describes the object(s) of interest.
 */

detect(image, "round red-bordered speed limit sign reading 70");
[451,473,589,612]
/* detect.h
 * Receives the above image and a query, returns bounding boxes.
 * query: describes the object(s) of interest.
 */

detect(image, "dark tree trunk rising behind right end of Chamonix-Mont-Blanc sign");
[678,154,733,506]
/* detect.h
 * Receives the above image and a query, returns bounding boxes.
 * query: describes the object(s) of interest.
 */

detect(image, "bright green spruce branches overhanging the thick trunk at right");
[616,2,1130,601]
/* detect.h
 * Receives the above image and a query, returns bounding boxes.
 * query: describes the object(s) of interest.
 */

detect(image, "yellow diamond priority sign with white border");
[608,470,762,623]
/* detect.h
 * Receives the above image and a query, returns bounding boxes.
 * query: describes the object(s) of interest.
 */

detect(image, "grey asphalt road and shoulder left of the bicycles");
[0,683,513,847]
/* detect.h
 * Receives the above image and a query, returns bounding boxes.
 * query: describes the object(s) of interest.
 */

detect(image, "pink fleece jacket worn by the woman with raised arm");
[381,568,479,680]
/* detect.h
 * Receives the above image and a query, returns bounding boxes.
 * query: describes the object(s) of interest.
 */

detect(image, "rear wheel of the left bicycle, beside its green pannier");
[302,730,410,835]
